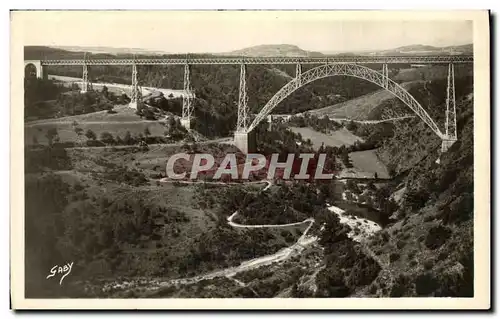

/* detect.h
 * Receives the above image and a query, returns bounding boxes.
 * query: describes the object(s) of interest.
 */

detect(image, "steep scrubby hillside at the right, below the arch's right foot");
[358,97,474,297]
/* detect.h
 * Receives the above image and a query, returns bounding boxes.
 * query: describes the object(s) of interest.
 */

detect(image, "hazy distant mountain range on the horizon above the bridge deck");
[24,44,473,59]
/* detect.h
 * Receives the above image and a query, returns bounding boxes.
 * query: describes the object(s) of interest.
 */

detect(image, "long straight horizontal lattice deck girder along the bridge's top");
[41,55,474,65]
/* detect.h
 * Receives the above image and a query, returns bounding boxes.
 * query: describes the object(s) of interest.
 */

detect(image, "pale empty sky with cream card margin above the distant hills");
[12,11,473,53]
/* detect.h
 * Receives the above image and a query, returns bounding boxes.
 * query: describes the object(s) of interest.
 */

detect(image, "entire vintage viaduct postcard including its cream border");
[10,11,490,309]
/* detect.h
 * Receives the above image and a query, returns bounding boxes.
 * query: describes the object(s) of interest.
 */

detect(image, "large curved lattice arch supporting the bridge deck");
[247,64,444,139]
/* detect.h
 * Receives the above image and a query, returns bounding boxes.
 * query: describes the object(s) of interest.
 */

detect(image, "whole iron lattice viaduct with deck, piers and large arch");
[27,55,473,152]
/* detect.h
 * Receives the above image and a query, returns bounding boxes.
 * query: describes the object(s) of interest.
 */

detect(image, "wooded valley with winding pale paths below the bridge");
[24,44,474,298]
